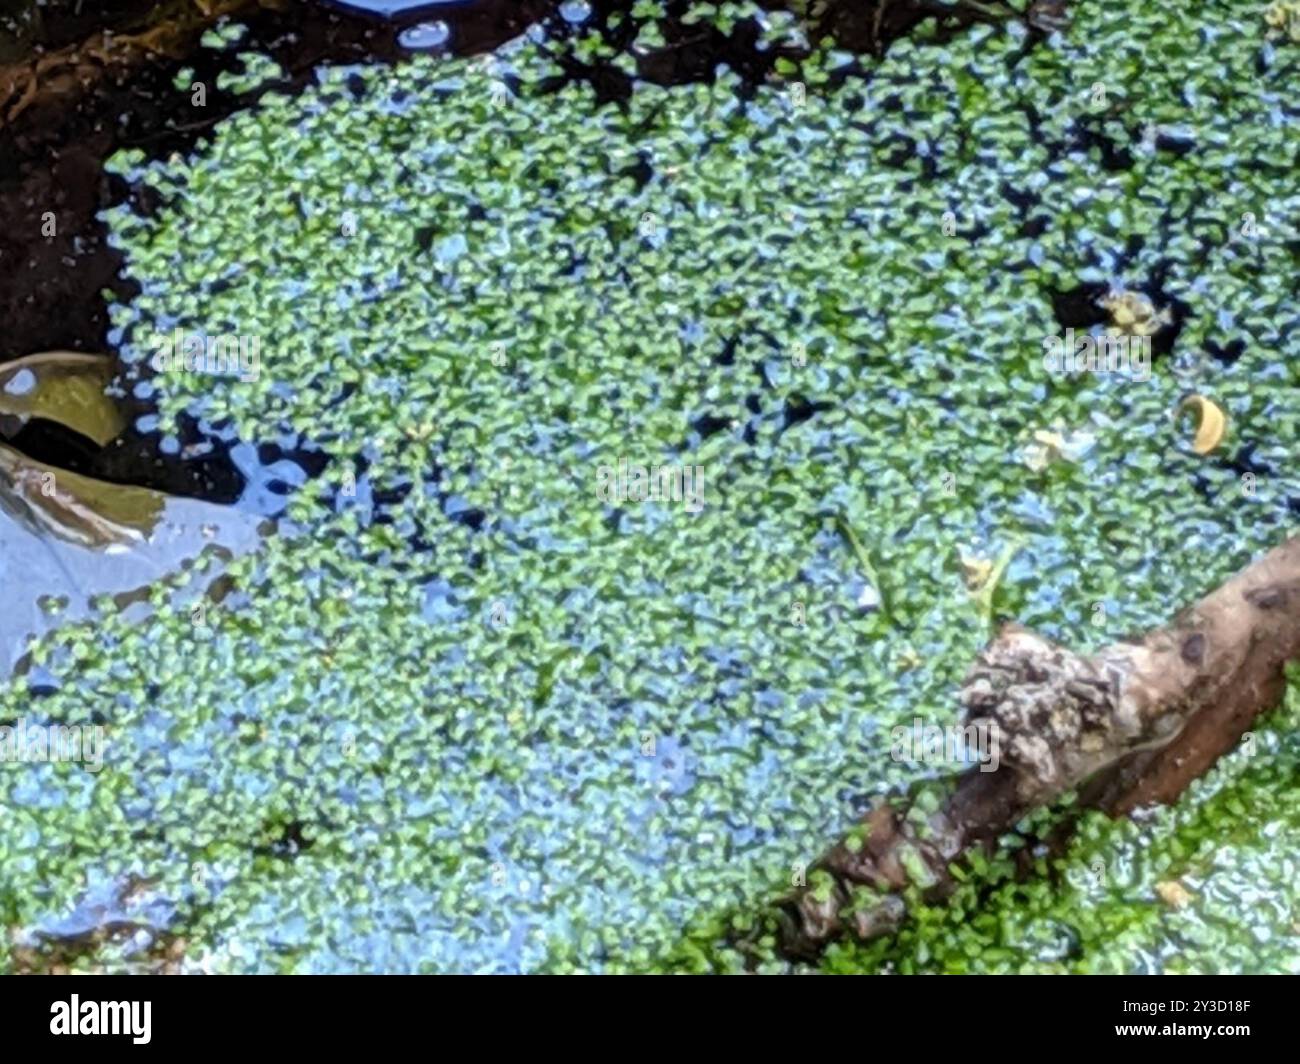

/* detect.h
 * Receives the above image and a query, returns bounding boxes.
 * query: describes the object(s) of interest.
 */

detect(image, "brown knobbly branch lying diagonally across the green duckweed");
[777,537,1300,960]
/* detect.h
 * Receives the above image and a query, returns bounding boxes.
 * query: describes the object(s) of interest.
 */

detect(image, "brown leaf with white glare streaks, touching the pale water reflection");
[0,444,165,549]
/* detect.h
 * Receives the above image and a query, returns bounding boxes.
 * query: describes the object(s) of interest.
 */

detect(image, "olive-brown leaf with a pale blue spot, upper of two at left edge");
[0,351,126,446]
